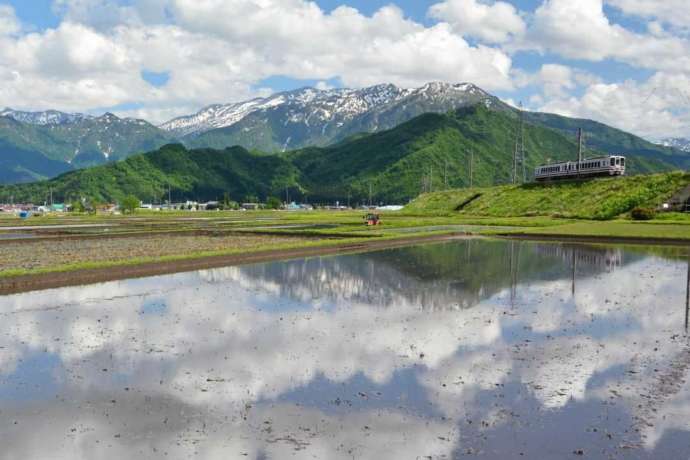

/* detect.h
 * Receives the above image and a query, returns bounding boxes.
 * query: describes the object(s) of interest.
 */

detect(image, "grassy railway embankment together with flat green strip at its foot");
[405,172,690,241]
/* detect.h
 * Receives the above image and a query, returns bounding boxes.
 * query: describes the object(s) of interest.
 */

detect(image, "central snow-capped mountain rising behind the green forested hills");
[160,83,502,151]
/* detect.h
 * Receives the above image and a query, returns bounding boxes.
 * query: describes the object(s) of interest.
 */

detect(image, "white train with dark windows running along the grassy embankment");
[534,155,625,182]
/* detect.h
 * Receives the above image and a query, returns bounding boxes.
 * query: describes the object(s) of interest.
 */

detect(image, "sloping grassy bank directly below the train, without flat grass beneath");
[405,172,690,219]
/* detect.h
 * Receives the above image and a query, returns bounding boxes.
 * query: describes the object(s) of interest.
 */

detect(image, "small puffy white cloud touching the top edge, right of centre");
[429,0,525,43]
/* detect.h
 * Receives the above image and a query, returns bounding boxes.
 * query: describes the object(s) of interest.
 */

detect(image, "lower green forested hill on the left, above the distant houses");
[0,144,298,202]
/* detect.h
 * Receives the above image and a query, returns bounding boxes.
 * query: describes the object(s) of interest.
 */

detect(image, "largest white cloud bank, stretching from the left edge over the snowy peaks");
[0,0,512,121]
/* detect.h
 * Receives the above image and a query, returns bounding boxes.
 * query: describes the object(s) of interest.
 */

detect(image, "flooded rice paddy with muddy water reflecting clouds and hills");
[0,240,690,460]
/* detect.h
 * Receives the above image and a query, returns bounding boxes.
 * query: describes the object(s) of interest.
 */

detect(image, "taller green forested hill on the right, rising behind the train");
[287,104,673,202]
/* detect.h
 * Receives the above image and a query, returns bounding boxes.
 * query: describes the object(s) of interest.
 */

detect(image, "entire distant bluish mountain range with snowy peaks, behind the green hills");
[0,83,690,183]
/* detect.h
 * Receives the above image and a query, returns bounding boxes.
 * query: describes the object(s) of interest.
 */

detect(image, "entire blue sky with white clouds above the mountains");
[0,0,690,140]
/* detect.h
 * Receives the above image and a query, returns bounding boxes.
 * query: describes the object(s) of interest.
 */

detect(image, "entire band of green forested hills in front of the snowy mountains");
[0,104,684,204]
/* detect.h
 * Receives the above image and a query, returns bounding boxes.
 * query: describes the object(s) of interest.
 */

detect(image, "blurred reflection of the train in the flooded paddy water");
[534,244,623,272]
